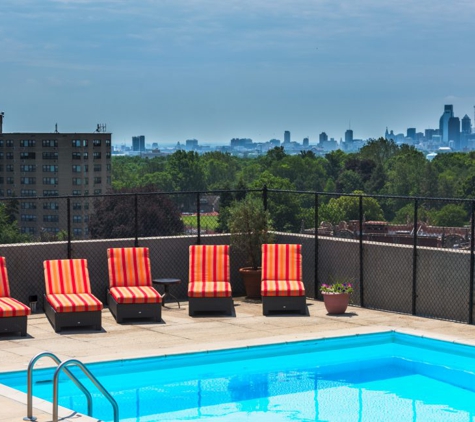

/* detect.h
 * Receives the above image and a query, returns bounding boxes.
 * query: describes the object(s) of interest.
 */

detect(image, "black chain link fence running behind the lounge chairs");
[0,187,475,324]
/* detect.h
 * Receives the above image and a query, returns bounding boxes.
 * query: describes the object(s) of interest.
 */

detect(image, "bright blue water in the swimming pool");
[0,332,475,422]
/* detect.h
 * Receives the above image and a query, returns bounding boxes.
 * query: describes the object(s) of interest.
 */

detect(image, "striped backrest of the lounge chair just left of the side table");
[107,248,152,287]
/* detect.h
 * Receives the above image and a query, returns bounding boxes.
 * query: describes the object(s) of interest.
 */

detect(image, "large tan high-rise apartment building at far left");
[0,122,111,238]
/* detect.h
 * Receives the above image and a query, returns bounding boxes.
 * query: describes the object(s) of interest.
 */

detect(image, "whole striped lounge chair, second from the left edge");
[43,259,103,333]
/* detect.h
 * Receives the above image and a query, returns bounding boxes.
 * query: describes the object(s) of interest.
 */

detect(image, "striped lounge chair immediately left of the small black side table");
[107,248,162,323]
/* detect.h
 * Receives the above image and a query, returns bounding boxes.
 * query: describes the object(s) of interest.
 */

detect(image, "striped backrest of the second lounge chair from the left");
[43,259,91,294]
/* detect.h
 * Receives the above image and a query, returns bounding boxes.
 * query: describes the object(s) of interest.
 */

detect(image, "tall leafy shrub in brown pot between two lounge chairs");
[228,195,272,299]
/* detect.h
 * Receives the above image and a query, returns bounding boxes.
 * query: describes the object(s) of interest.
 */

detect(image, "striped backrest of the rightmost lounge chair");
[262,244,302,281]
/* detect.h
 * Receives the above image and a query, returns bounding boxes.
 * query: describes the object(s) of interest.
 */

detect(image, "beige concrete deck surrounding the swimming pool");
[0,298,475,422]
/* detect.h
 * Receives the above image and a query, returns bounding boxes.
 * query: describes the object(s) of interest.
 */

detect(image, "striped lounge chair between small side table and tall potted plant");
[188,245,234,316]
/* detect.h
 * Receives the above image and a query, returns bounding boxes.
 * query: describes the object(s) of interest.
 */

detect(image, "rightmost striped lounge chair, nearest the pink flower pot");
[261,244,307,315]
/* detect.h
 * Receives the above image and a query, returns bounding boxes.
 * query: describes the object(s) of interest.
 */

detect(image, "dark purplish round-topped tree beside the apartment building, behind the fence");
[89,186,184,239]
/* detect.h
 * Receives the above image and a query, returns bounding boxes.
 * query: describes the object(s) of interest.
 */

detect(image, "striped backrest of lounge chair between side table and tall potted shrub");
[189,245,229,283]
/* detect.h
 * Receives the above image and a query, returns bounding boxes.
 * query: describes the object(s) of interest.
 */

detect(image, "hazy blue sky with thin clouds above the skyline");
[0,0,475,144]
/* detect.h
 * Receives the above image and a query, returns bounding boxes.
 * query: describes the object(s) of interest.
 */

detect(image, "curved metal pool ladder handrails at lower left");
[23,352,119,422]
